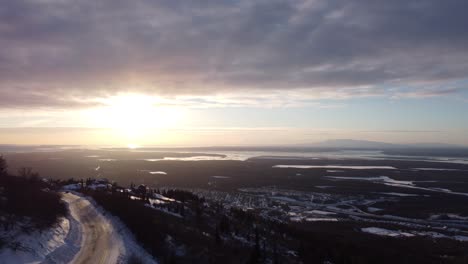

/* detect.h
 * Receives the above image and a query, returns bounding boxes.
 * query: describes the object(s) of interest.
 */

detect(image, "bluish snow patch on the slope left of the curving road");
[0,218,70,264]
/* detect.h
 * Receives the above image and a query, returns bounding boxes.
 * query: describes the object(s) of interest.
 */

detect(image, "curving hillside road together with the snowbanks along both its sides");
[0,192,157,264]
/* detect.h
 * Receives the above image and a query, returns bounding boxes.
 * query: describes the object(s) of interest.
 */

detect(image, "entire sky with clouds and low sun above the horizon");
[0,0,468,146]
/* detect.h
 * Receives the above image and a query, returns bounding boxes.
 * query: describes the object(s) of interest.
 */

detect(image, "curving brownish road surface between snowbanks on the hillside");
[63,193,125,264]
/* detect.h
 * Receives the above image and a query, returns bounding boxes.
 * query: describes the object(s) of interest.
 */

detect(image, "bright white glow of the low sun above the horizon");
[88,94,182,144]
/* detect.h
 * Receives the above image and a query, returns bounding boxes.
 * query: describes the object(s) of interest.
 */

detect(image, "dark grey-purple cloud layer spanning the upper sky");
[0,0,468,106]
